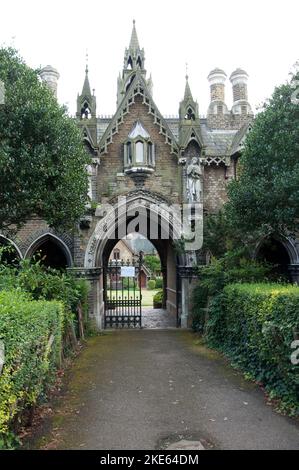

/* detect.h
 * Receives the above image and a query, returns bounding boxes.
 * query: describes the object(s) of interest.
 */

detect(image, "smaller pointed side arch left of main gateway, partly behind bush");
[25,232,73,268]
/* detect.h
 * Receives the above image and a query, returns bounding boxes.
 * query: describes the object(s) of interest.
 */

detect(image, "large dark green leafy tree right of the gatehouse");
[225,68,299,237]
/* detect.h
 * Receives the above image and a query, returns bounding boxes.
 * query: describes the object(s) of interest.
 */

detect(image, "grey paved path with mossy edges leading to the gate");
[26,330,299,450]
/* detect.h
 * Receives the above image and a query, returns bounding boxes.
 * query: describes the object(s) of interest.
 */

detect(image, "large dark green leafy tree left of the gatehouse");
[0,48,89,234]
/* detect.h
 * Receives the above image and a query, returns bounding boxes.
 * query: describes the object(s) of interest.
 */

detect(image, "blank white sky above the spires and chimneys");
[0,0,299,115]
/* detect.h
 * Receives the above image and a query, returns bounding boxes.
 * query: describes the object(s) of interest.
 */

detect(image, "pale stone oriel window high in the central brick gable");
[124,121,155,173]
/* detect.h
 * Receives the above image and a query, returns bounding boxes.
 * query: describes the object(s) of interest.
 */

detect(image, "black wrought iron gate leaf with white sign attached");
[104,255,142,328]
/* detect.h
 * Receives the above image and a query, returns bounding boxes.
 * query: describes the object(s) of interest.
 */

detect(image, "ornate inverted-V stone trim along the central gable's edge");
[99,71,179,155]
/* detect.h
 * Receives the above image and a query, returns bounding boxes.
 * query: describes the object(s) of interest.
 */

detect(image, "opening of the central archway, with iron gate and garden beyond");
[103,233,177,328]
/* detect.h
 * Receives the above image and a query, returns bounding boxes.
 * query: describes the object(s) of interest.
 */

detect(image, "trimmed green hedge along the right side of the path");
[206,284,299,415]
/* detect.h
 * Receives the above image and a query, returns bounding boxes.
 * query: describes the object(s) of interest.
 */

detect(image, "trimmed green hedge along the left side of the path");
[0,290,64,448]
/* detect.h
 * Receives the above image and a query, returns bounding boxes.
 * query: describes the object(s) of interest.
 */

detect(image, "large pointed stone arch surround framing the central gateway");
[85,192,184,328]
